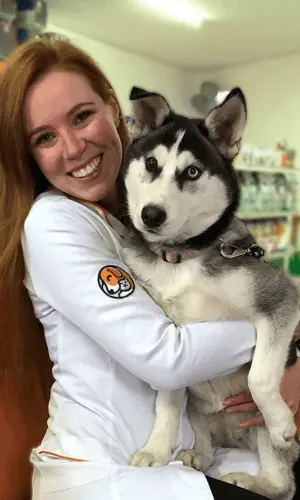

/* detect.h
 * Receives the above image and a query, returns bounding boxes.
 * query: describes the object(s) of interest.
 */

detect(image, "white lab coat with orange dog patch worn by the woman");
[22,190,258,500]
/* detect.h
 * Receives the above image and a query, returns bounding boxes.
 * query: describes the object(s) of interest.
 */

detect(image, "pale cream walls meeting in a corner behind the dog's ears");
[47,25,300,155]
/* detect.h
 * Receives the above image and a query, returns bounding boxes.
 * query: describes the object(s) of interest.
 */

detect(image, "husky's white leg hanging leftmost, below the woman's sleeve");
[130,389,185,467]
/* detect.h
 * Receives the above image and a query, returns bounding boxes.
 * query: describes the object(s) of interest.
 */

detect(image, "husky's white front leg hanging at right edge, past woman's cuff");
[248,311,299,449]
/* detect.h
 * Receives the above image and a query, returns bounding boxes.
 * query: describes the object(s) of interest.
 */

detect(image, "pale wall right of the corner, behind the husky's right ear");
[192,52,300,155]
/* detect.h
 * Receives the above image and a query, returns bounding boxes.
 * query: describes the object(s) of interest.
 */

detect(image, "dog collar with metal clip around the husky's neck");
[161,240,265,264]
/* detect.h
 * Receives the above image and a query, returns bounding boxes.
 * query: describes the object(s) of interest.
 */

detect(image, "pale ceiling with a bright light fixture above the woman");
[48,0,300,72]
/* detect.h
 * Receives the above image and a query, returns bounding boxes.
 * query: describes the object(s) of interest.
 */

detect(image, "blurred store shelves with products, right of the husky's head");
[234,141,300,274]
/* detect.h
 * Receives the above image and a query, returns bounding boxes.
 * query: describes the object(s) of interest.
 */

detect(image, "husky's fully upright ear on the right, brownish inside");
[204,88,247,160]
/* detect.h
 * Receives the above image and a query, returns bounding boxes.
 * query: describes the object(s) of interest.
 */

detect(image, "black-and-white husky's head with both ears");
[123,87,247,248]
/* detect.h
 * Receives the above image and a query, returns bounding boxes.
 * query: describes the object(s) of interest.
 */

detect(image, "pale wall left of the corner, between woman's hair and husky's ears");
[47,25,193,114]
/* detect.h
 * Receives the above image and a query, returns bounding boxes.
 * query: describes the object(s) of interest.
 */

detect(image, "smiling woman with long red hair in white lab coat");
[0,38,299,500]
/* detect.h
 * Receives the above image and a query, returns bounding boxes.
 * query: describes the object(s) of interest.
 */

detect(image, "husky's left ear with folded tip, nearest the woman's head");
[130,87,171,139]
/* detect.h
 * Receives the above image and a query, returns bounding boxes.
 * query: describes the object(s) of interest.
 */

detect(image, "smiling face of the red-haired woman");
[24,70,122,202]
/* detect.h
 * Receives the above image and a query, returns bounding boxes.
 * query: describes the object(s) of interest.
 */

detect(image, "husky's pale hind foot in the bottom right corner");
[220,428,299,500]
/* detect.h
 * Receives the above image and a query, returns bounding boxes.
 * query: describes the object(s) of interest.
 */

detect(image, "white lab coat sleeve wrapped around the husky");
[22,195,256,390]
